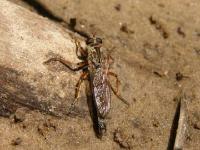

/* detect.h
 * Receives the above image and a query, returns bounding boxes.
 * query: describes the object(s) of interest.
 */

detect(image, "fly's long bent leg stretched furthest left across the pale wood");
[44,57,88,71]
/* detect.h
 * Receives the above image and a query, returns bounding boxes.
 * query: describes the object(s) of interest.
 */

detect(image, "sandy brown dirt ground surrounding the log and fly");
[0,0,200,150]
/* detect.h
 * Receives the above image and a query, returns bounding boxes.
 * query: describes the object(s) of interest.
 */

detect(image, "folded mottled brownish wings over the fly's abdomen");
[92,68,111,118]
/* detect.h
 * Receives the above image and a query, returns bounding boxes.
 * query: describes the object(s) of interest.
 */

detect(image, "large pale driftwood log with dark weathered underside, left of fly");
[0,0,85,116]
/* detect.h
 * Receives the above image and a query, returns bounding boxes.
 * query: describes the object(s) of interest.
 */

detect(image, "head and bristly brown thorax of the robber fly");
[86,37,103,68]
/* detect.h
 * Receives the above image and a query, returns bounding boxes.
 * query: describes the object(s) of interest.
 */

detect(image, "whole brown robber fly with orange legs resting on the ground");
[45,36,129,137]
